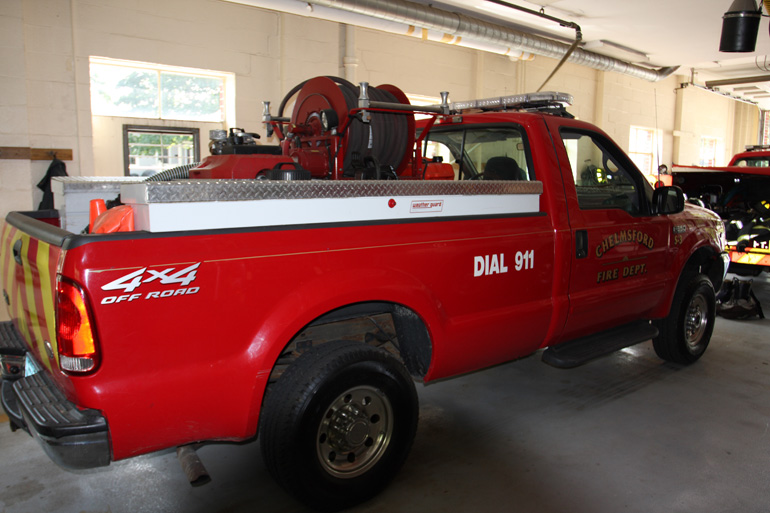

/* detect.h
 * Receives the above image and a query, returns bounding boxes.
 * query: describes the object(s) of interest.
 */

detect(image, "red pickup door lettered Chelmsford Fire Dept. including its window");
[547,118,671,338]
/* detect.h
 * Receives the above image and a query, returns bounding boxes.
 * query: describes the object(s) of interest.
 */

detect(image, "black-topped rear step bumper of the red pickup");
[0,322,111,469]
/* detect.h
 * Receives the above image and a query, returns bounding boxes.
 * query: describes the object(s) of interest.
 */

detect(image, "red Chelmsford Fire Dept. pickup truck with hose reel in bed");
[0,77,727,510]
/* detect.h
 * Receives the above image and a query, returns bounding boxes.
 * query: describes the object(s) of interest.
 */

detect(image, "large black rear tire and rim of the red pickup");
[260,342,419,511]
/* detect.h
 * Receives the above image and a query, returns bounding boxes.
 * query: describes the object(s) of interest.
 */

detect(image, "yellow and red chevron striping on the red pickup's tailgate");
[0,223,61,369]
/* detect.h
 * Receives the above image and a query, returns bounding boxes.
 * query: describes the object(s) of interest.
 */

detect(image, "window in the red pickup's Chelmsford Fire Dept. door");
[561,128,645,215]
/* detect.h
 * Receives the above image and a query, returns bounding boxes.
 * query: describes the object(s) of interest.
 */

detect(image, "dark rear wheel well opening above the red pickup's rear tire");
[268,302,432,386]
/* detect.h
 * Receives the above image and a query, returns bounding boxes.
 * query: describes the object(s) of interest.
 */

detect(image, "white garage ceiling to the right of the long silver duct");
[420,0,770,109]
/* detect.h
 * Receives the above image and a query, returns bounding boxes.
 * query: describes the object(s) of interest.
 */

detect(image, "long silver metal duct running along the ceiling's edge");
[306,0,679,82]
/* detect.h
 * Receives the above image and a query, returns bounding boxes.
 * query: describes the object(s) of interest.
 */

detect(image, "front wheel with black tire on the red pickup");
[652,274,716,365]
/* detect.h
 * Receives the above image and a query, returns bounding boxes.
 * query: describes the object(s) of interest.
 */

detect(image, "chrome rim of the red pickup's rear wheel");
[316,386,393,479]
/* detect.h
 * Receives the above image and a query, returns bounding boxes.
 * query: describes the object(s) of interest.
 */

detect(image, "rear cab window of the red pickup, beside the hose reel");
[423,126,535,181]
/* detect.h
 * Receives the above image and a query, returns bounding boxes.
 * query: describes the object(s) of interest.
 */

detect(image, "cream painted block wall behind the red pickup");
[0,0,758,320]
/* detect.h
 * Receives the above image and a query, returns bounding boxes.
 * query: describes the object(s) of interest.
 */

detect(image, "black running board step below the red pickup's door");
[543,321,658,369]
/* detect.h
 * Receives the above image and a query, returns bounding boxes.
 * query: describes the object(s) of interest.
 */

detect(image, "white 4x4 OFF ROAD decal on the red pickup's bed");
[101,262,201,305]
